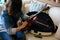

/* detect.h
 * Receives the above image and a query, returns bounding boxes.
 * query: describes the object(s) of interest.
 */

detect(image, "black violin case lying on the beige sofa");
[27,12,57,33]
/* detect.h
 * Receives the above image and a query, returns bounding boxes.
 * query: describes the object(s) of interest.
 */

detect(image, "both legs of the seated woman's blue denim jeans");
[0,31,26,40]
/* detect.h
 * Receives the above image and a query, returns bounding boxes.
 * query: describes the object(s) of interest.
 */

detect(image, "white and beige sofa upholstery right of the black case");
[49,7,60,40]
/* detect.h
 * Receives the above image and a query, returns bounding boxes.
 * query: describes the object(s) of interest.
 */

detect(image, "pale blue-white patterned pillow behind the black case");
[29,1,47,12]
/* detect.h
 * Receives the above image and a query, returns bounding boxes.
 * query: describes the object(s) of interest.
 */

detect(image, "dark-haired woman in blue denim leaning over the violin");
[2,0,28,40]
